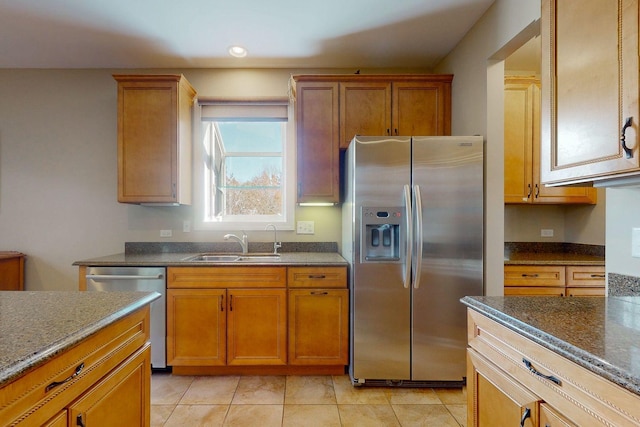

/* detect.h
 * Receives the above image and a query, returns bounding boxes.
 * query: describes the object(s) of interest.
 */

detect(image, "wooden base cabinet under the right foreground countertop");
[467,309,640,427]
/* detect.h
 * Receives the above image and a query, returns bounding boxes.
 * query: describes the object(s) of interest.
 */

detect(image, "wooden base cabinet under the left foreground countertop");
[0,306,151,427]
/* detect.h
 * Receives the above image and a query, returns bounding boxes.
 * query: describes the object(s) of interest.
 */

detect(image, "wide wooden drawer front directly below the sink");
[167,266,287,289]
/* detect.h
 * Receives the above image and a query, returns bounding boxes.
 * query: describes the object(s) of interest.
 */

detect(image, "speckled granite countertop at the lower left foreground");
[0,291,160,387]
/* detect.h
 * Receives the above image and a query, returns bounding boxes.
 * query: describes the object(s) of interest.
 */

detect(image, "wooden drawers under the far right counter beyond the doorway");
[504,265,605,297]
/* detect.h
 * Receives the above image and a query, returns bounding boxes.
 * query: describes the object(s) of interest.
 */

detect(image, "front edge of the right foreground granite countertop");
[460,296,640,394]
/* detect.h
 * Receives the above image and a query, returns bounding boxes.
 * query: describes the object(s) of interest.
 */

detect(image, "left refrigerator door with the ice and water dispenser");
[343,137,411,381]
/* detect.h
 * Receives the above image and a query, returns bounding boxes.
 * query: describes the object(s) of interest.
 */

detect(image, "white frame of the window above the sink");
[193,98,296,231]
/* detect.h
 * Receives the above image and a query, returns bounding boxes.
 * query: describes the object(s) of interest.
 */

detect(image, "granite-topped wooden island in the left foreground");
[0,291,159,425]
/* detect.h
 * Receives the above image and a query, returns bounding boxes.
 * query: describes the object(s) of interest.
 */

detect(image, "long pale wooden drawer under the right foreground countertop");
[468,309,640,426]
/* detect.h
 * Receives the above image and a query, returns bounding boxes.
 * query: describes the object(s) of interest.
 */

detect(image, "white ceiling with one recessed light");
[0,0,494,69]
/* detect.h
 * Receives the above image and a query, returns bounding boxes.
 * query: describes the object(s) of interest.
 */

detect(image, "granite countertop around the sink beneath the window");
[73,252,347,266]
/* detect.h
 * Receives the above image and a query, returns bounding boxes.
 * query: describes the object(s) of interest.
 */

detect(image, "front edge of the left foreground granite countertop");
[0,292,161,388]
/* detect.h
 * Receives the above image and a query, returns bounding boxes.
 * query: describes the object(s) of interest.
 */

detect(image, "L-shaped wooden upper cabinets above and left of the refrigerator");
[292,74,453,204]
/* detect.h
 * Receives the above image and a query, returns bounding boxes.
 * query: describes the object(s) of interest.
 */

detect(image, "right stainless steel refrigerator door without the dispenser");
[412,137,484,381]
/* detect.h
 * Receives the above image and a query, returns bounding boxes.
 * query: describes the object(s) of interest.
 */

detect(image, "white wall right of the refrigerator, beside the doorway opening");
[435,0,540,295]
